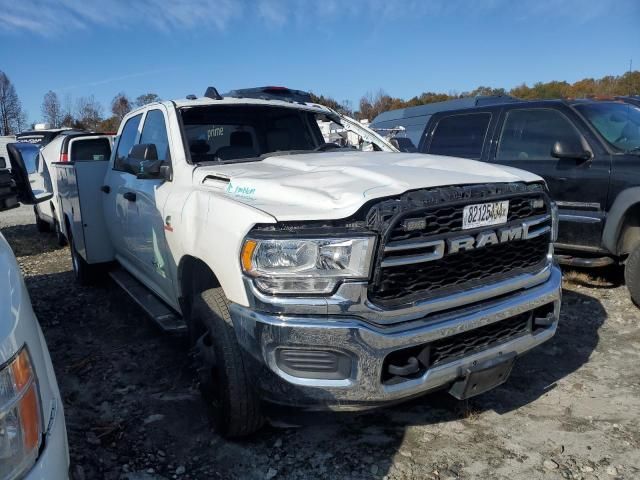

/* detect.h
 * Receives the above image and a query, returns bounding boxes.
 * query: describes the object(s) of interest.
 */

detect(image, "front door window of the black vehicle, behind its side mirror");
[496,108,580,161]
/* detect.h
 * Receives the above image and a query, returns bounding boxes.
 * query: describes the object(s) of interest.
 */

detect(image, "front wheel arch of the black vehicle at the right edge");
[602,187,640,255]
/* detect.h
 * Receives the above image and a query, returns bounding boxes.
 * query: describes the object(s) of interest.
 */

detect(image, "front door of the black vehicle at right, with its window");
[488,106,611,251]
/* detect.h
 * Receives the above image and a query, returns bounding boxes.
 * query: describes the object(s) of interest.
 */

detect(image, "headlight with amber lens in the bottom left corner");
[0,347,42,480]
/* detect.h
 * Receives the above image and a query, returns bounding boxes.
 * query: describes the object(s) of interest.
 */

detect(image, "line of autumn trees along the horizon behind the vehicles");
[0,70,640,135]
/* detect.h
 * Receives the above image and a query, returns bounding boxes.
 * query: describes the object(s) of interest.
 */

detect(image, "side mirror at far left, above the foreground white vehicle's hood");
[7,143,53,205]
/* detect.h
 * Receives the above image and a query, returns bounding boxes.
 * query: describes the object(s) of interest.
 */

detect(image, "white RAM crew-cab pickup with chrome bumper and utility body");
[55,88,561,436]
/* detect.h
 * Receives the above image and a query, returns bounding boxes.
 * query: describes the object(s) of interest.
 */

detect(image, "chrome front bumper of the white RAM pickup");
[230,264,562,409]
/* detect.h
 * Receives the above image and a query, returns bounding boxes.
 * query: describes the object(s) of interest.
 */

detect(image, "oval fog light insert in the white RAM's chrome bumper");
[276,348,352,380]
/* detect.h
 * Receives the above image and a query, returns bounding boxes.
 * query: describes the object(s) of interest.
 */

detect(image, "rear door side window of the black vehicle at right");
[429,113,491,160]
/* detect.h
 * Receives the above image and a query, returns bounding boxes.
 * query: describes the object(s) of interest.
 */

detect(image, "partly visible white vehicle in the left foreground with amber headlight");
[0,147,69,480]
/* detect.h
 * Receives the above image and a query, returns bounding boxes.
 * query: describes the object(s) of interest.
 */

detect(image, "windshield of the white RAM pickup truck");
[181,105,390,163]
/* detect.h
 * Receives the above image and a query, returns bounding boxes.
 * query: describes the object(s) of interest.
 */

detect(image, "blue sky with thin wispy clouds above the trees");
[0,0,640,121]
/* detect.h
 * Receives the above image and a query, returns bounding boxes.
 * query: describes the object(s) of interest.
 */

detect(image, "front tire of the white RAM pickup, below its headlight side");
[190,288,264,438]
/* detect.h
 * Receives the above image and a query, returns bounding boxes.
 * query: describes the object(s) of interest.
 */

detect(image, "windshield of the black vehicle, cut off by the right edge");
[575,103,640,152]
